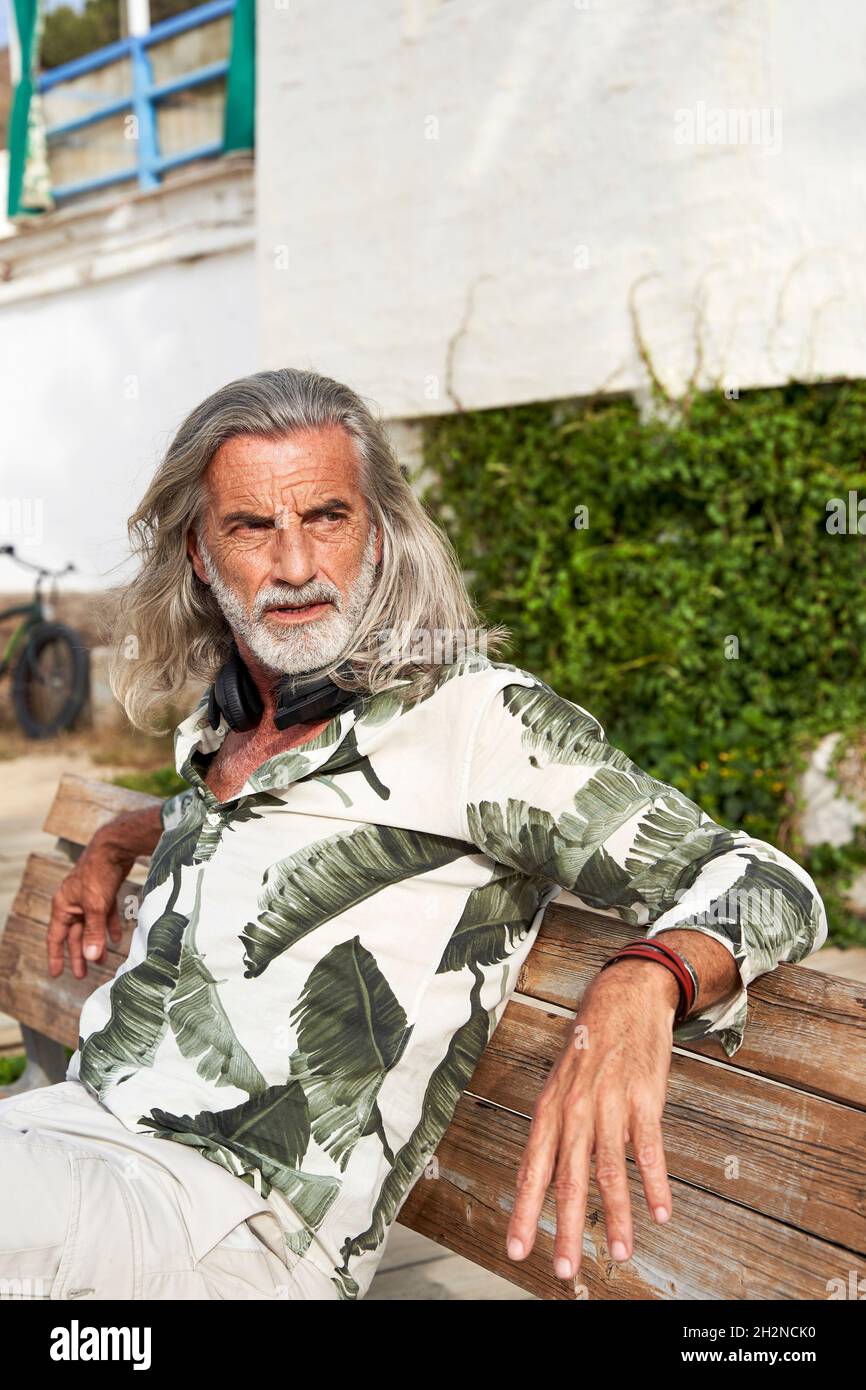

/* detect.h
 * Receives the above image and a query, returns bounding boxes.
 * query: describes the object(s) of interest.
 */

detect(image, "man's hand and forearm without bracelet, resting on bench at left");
[47,806,163,980]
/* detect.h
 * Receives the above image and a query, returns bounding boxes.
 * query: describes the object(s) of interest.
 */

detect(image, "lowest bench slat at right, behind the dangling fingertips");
[398,1095,866,1300]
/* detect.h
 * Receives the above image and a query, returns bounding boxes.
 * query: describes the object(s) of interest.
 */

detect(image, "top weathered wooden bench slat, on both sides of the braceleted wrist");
[517,904,866,1106]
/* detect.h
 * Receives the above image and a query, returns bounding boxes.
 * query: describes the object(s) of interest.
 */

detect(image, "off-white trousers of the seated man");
[0,1097,311,1300]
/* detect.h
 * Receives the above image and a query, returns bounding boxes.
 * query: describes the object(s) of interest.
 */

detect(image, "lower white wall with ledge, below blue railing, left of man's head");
[0,159,260,592]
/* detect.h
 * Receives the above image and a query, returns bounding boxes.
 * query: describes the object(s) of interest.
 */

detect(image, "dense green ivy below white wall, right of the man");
[424,382,866,941]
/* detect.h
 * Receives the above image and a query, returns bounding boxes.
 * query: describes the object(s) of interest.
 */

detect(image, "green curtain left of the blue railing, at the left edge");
[7,0,54,217]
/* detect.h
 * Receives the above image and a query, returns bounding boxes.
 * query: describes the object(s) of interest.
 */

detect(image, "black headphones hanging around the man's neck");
[207,642,359,733]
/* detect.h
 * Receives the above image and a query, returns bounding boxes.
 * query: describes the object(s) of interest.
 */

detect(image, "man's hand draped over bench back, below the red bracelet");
[507,960,680,1279]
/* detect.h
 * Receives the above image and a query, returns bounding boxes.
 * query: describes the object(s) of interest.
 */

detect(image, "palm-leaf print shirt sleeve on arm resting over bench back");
[460,673,827,1056]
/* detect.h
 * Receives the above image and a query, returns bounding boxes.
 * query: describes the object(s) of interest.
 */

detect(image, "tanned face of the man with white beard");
[188,427,382,673]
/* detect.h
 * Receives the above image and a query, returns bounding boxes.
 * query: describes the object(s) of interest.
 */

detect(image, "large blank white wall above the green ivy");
[256,0,866,417]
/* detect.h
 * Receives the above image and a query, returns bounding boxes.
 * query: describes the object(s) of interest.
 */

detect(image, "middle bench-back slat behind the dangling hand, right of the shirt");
[467,999,866,1255]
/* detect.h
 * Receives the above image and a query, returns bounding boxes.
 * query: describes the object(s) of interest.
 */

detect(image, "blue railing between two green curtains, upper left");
[39,0,235,202]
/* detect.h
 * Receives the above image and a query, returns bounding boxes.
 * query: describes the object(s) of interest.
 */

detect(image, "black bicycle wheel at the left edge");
[13,623,90,738]
